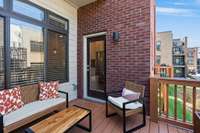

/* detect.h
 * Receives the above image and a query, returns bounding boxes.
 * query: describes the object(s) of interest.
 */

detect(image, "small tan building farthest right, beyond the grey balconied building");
[185,48,198,74]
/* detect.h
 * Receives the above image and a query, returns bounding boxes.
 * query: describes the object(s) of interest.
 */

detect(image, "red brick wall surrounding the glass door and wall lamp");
[77,0,154,110]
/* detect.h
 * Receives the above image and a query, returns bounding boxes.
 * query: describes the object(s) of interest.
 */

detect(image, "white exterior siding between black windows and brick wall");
[31,0,77,100]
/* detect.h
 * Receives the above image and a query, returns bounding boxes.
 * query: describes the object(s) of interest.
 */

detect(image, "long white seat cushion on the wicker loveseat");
[3,98,66,126]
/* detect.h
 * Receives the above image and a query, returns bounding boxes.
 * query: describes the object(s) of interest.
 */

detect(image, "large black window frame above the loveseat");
[0,0,69,90]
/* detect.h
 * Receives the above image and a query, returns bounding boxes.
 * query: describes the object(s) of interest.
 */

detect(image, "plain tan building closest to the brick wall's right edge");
[156,31,173,66]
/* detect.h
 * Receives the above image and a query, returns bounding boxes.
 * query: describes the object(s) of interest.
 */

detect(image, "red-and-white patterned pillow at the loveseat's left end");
[0,86,24,115]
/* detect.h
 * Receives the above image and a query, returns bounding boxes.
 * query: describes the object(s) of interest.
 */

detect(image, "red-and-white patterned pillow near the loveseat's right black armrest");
[39,81,59,100]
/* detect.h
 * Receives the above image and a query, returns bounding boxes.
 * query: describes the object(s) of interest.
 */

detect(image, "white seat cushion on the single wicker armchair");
[108,96,142,109]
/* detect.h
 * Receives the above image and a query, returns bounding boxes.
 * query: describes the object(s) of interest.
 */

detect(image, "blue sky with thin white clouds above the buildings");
[156,0,200,47]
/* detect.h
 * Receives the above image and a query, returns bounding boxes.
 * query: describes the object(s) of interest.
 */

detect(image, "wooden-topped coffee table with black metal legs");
[26,105,92,133]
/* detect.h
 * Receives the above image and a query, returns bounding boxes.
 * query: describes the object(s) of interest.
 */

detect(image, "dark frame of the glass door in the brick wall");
[87,35,106,100]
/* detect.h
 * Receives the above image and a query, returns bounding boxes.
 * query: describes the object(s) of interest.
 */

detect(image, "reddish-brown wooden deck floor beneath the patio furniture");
[70,99,192,133]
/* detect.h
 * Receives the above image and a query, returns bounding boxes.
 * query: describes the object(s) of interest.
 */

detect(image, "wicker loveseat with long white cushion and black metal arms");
[0,84,68,133]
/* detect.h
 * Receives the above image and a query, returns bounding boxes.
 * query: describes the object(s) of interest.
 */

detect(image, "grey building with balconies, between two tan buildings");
[172,37,188,78]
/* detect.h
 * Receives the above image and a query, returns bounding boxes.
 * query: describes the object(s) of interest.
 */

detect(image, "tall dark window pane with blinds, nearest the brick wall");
[46,31,67,82]
